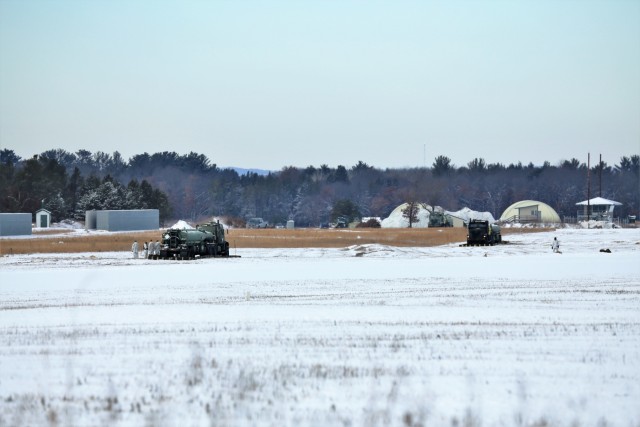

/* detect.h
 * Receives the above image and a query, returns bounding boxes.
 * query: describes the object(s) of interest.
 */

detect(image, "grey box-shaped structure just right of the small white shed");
[85,209,160,231]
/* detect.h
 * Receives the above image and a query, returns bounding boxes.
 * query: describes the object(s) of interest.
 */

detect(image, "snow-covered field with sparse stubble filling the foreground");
[0,229,640,426]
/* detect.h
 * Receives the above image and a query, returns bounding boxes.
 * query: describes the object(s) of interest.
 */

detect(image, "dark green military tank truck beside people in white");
[157,221,229,260]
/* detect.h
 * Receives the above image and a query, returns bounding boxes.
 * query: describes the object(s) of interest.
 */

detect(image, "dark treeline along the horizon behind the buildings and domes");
[0,149,640,226]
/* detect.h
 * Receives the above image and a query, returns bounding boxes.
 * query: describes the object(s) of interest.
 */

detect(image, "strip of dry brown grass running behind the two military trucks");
[0,228,549,255]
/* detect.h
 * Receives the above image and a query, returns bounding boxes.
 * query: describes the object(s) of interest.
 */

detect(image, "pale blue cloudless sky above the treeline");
[0,0,640,169]
